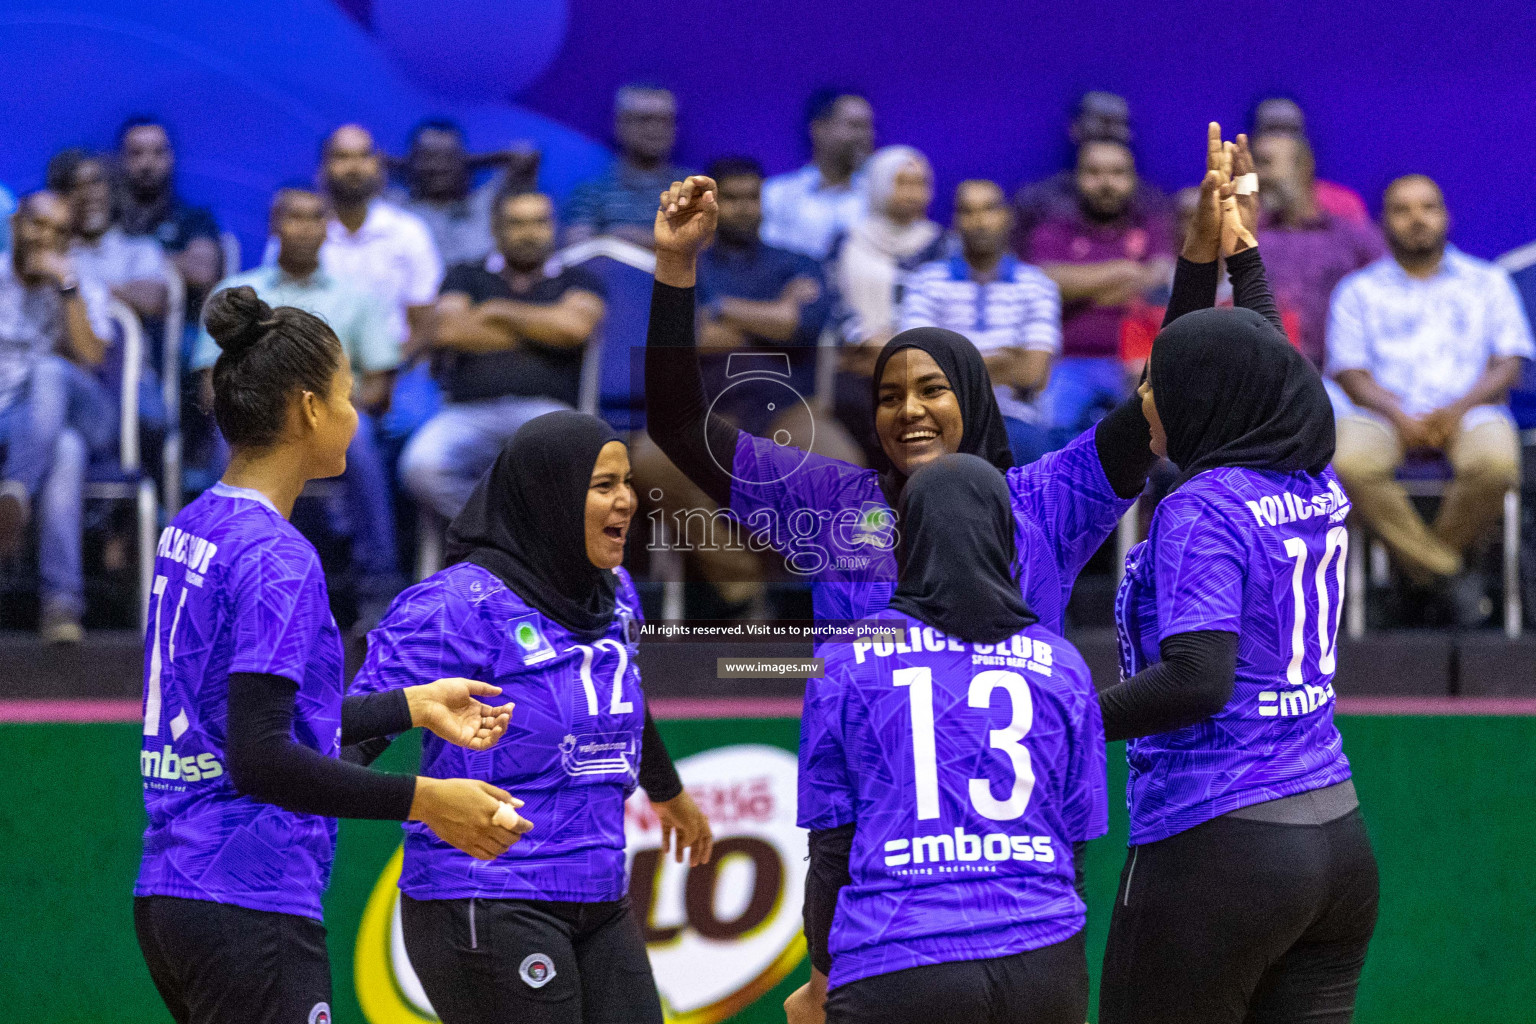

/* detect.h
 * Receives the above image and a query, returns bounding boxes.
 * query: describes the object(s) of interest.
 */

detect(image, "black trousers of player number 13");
[826,932,1087,1024]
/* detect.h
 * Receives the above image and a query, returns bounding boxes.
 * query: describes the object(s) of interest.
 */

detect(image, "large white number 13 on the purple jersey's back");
[891,666,1035,821]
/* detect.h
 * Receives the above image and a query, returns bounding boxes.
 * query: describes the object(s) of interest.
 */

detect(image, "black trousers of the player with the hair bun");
[134,897,333,1024]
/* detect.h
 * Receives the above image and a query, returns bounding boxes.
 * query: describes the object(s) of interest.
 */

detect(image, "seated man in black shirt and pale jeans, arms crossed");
[399,192,602,519]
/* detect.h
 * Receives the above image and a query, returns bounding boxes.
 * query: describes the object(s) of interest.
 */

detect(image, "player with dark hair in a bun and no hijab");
[134,287,534,1024]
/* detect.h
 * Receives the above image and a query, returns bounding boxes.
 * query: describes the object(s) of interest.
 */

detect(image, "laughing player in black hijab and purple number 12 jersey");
[355,413,711,1024]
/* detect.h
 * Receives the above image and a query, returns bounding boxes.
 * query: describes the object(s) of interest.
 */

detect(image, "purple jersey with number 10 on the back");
[1115,468,1350,846]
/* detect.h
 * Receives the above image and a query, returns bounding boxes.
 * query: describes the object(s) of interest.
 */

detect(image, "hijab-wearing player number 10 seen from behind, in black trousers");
[1098,194,1378,1024]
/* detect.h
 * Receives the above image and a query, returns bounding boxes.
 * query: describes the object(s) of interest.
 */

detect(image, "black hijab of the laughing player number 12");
[445,413,621,642]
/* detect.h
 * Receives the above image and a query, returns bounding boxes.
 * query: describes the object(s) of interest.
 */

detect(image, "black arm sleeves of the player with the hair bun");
[224,672,416,821]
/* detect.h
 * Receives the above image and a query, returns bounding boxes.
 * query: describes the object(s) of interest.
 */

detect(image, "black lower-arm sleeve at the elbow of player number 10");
[1098,629,1238,740]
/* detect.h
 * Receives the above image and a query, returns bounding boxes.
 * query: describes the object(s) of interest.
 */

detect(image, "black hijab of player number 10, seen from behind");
[1149,309,1333,484]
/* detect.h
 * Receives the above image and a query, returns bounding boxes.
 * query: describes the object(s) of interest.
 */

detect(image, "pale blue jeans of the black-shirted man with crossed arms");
[399,395,570,519]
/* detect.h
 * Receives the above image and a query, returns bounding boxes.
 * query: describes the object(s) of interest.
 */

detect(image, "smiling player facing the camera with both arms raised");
[645,124,1263,631]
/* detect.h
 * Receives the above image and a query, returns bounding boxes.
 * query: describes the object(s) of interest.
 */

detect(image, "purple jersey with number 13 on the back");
[799,611,1107,989]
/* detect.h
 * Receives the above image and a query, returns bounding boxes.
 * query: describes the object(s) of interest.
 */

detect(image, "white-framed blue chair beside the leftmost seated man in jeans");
[84,301,160,629]
